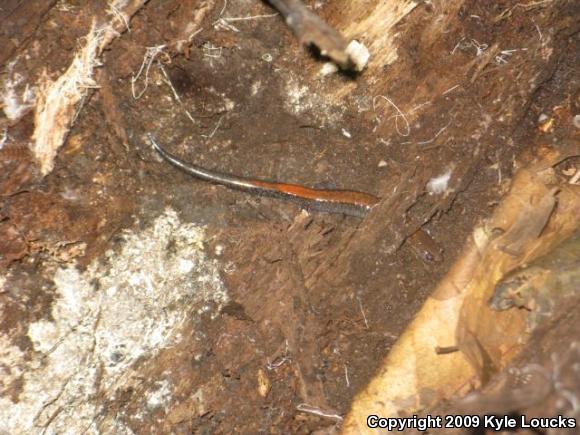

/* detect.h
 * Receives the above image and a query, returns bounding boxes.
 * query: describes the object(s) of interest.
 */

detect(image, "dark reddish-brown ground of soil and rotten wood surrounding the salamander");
[0,0,580,433]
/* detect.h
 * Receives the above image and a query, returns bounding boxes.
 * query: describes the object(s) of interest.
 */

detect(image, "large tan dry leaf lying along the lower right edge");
[343,155,580,434]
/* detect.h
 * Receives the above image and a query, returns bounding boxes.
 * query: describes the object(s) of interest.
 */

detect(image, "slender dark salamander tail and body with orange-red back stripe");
[147,134,379,218]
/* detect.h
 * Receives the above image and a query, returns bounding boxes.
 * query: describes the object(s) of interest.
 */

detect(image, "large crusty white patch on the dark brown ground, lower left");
[0,210,227,434]
